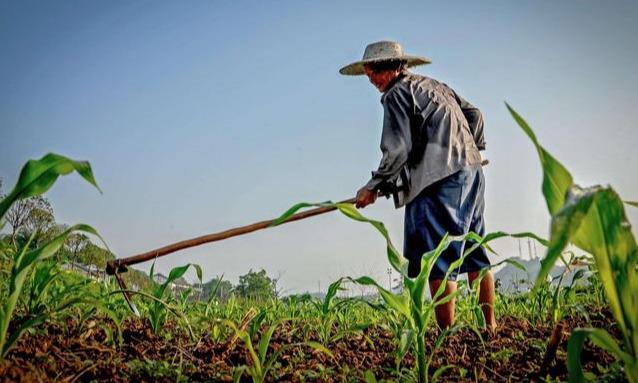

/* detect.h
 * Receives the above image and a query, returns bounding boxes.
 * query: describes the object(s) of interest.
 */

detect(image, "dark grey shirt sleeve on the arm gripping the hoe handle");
[366,91,412,191]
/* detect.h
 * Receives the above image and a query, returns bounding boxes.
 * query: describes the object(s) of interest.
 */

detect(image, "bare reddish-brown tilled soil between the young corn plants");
[0,312,623,383]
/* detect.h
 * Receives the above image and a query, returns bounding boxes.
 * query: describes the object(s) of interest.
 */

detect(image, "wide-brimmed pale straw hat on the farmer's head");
[339,41,432,76]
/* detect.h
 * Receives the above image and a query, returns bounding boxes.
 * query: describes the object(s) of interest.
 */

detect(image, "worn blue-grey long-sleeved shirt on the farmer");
[366,71,485,207]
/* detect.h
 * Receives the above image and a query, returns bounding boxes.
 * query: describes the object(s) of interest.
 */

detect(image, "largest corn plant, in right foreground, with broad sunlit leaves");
[507,105,638,383]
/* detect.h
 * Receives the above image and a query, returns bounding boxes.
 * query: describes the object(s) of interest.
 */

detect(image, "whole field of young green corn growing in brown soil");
[0,109,638,383]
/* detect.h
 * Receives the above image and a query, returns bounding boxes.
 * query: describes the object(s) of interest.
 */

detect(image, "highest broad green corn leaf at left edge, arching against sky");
[0,153,101,220]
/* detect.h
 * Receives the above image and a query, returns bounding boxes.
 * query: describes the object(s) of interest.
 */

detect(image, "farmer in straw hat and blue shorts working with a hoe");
[339,41,496,331]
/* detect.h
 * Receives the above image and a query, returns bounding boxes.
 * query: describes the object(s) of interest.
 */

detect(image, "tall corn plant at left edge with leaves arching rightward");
[0,153,99,360]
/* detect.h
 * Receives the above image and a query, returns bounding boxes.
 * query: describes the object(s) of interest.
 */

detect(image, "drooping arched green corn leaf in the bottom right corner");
[567,328,638,383]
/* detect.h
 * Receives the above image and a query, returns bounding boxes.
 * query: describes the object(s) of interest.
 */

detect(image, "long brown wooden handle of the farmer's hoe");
[106,198,355,275]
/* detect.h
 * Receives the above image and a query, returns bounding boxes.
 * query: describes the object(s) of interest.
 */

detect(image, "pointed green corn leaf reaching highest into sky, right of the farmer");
[505,103,573,215]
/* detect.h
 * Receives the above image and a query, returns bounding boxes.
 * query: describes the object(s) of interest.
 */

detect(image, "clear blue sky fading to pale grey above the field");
[0,0,638,293]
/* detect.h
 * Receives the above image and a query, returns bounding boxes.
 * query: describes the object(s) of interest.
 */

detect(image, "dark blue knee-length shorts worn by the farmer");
[403,165,490,280]
